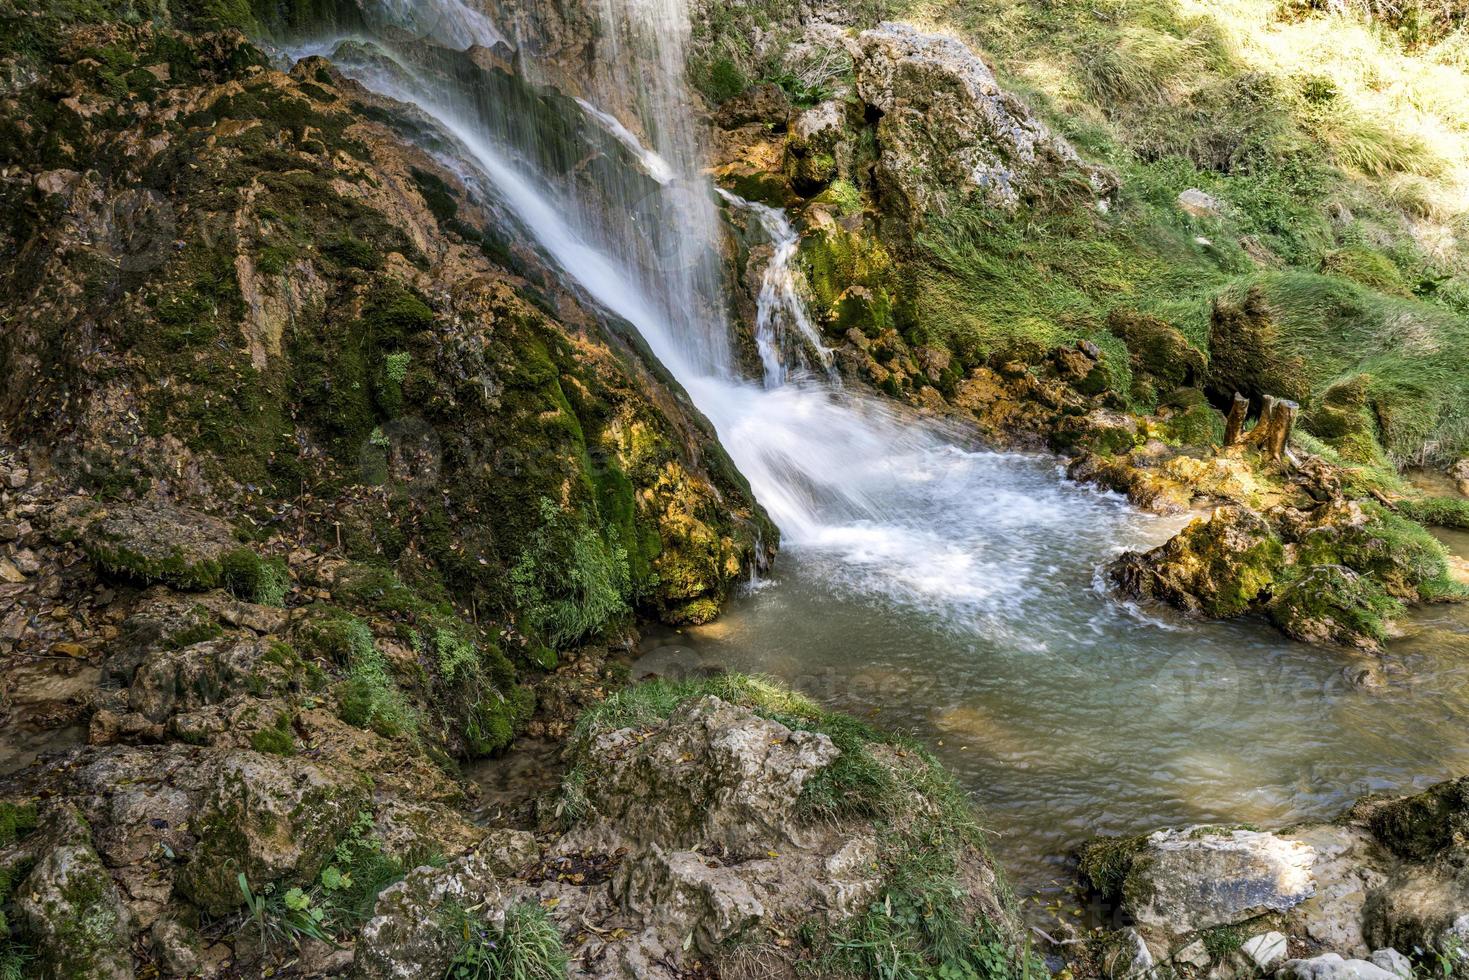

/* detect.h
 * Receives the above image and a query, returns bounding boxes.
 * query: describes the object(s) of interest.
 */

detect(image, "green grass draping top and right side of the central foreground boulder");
[561,674,1043,980]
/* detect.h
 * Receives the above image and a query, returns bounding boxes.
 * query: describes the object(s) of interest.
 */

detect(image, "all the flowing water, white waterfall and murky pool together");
[298,0,1469,890]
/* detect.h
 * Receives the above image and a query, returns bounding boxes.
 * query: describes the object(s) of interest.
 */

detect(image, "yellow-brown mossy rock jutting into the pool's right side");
[1109,507,1285,619]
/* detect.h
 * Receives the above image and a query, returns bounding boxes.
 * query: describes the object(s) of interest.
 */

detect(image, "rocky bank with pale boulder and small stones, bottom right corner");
[1074,779,1469,980]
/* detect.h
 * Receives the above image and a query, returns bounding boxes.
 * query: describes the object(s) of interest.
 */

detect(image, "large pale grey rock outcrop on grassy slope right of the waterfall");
[853,24,1106,217]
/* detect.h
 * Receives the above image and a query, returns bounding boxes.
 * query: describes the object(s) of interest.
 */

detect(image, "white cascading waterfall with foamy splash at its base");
[294,0,1034,581]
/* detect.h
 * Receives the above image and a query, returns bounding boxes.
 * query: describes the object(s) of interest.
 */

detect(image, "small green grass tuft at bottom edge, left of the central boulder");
[447,901,569,980]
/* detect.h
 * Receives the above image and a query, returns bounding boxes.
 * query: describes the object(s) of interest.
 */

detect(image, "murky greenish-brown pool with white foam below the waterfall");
[635,454,1469,895]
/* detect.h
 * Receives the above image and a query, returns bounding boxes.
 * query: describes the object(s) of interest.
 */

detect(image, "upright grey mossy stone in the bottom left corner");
[15,843,134,980]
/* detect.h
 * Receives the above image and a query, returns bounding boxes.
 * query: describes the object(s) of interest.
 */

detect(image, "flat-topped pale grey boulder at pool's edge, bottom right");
[1122,830,1315,934]
